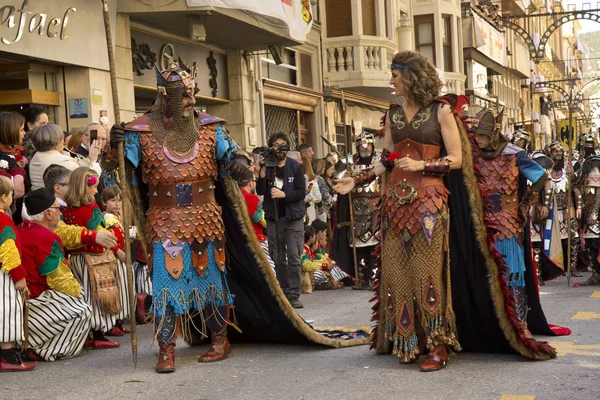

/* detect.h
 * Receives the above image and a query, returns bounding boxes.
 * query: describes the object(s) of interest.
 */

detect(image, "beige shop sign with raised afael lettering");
[0,0,110,70]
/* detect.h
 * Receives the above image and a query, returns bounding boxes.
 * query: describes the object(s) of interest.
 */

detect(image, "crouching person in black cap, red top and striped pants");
[17,189,95,361]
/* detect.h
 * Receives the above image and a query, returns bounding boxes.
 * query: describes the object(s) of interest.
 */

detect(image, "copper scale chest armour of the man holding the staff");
[139,119,225,272]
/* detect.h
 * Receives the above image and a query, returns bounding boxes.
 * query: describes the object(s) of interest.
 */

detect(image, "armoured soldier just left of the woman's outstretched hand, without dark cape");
[348,130,380,289]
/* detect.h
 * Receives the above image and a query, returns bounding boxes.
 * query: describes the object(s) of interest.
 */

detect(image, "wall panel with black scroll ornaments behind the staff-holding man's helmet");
[131,30,229,100]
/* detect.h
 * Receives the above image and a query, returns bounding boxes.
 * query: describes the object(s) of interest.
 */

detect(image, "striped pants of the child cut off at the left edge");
[0,271,25,343]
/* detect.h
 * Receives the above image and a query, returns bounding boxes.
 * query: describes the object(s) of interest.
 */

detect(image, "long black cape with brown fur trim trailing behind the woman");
[445,96,570,360]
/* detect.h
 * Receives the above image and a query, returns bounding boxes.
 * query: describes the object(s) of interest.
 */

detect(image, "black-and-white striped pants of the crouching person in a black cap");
[29,290,92,361]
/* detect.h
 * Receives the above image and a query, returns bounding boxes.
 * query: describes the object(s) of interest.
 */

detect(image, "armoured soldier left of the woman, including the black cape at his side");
[331,125,381,290]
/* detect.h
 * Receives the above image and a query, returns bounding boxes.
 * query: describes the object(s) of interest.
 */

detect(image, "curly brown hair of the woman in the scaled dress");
[392,50,442,106]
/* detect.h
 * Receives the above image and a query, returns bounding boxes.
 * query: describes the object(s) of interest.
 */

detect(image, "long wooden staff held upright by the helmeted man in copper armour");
[102,0,137,368]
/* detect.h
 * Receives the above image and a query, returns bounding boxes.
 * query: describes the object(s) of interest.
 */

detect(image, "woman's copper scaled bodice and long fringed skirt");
[373,101,460,363]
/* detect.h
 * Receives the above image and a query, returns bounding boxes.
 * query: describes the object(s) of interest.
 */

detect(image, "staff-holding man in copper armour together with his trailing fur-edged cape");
[106,61,368,372]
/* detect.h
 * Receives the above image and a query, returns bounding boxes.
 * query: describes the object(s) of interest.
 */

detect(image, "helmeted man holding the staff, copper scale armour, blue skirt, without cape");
[105,60,249,373]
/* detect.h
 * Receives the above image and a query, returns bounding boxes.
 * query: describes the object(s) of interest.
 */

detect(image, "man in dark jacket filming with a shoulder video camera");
[256,132,306,308]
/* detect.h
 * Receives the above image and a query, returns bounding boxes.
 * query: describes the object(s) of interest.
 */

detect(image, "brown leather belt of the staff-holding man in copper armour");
[150,179,215,208]
